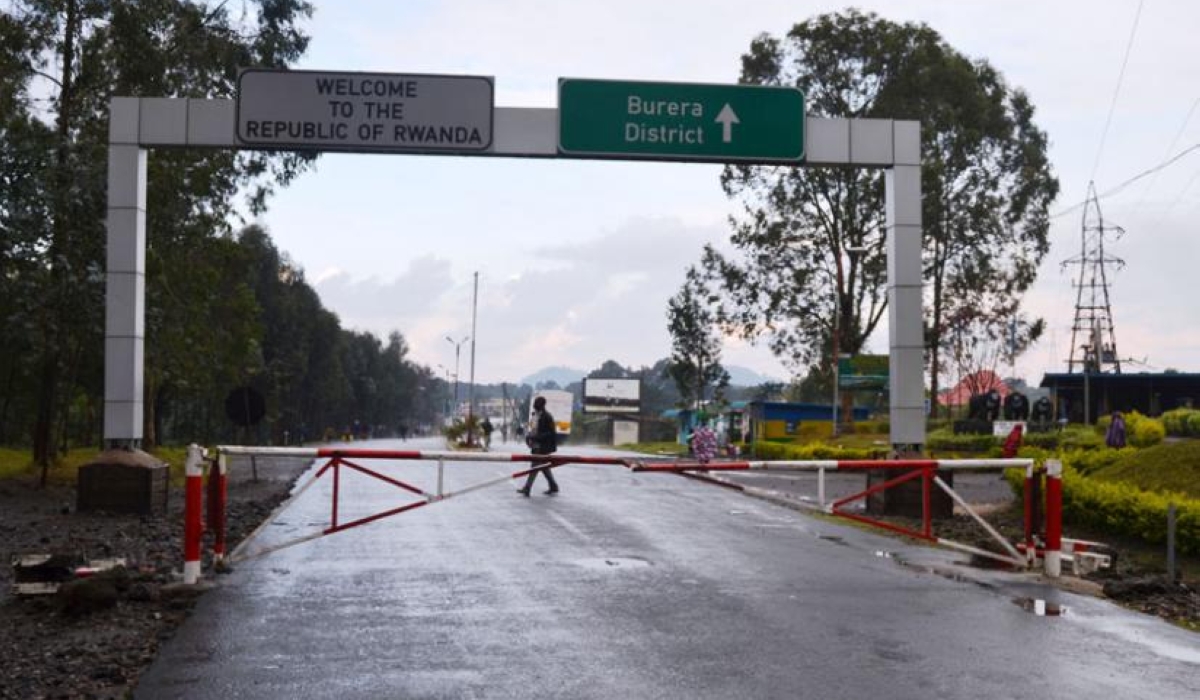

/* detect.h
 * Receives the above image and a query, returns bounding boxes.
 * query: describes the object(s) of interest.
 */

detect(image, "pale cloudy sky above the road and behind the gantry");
[248,0,1200,383]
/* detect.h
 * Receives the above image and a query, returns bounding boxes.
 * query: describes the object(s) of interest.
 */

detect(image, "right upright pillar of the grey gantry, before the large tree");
[886,121,925,445]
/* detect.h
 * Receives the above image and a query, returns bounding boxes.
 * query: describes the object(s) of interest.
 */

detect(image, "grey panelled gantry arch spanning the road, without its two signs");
[104,82,925,451]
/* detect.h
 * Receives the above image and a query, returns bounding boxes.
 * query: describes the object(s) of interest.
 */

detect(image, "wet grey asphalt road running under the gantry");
[136,441,1200,700]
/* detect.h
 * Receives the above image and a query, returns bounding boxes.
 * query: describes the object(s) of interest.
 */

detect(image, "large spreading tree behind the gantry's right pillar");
[703,10,1058,415]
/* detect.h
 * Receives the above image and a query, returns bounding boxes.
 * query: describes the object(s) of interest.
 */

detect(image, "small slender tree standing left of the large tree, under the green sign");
[667,268,730,408]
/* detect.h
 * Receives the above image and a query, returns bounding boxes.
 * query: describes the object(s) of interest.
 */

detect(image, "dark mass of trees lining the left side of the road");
[0,0,443,456]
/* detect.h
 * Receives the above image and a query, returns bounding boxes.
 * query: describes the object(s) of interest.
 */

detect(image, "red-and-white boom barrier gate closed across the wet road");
[184,445,1062,584]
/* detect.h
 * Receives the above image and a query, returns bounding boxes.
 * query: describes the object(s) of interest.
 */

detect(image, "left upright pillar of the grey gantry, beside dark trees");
[104,97,146,447]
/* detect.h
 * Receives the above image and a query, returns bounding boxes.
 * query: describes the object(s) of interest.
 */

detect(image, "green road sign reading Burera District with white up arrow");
[558,78,804,163]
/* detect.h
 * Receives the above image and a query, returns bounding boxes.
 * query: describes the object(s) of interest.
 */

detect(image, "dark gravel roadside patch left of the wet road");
[0,457,308,700]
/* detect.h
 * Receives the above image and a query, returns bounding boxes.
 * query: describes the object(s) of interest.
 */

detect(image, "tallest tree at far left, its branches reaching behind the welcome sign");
[0,0,312,465]
